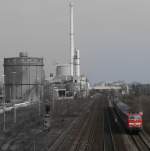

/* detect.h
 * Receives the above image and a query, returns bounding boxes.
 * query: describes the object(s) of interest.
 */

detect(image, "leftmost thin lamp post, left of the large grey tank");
[2,75,6,131]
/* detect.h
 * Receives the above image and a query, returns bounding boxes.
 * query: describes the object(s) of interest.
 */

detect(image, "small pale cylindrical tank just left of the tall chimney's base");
[56,64,70,77]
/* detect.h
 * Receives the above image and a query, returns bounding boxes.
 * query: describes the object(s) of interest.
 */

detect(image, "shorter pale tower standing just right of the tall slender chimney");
[74,49,80,78]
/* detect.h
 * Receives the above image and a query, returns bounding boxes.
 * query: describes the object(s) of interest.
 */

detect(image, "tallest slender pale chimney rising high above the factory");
[69,1,74,76]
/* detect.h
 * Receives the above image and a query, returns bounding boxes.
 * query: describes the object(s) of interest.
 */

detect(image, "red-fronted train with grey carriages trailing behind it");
[114,101,143,132]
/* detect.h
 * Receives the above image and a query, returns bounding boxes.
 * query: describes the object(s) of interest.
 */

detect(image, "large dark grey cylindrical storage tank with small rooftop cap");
[4,53,44,102]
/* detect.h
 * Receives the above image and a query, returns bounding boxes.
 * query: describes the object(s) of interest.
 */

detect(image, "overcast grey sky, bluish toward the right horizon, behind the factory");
[0,0,150,82]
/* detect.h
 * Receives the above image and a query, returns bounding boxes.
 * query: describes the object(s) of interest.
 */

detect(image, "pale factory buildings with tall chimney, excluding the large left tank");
[51,1,89,99]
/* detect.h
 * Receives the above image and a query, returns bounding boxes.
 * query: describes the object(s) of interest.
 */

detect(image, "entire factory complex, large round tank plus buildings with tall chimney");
[0,2,89,103]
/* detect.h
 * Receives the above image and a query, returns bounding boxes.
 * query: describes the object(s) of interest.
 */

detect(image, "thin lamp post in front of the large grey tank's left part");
[12,72,17,123]
